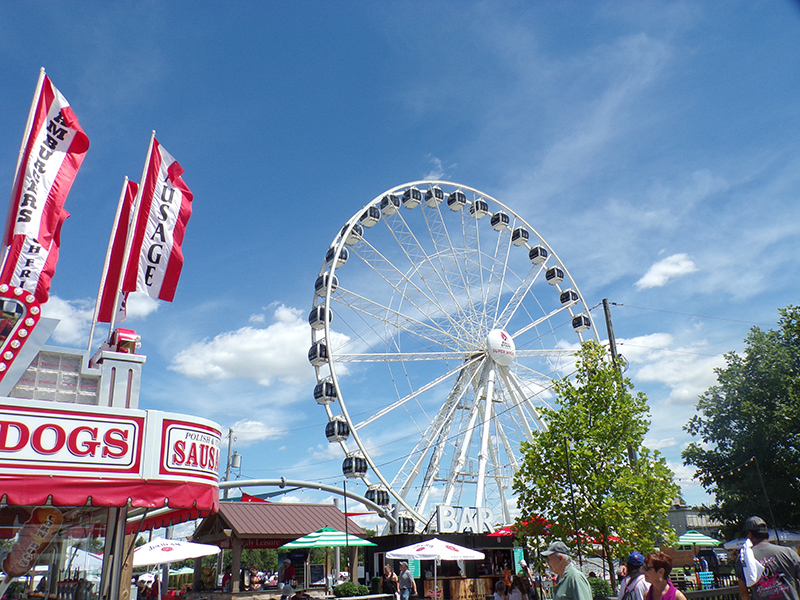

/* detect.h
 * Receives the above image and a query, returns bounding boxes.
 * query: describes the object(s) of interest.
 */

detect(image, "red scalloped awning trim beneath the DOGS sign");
[0,475,219,512]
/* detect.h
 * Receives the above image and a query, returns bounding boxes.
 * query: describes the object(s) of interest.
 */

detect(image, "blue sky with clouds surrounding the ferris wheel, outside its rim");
[0,0,800,524]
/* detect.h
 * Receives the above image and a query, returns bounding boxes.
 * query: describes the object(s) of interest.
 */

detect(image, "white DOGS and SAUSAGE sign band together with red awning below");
[0,398,221,508]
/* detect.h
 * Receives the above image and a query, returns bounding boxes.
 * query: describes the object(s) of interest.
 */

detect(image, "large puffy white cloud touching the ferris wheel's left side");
[169,305,346,386]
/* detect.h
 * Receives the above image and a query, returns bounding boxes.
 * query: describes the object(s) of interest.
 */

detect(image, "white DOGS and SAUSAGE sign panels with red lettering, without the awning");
[0,399,221,486]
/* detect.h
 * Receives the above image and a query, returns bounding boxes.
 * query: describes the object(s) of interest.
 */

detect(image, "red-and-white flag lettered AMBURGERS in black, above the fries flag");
[3,75,89,250]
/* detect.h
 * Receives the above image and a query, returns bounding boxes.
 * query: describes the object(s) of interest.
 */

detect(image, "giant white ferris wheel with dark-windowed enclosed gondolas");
[308,181,597,531]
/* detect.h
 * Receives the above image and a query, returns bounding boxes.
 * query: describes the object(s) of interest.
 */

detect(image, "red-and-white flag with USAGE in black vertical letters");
[122,138,192,302]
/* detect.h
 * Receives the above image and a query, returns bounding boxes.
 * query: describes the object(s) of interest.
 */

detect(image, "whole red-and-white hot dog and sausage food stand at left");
[0,332,221,600]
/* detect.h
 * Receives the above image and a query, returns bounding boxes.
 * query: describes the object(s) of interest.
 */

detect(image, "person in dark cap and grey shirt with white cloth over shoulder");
[734,516,800,600]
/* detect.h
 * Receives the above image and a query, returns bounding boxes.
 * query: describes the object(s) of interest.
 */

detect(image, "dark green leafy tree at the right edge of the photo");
[683,306,800,533]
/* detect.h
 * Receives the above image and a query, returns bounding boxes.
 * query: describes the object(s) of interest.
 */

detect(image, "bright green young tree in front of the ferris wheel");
[514,342,678,586]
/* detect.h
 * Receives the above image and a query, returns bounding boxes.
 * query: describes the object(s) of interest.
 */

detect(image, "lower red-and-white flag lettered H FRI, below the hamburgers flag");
[0,210,69,304]
